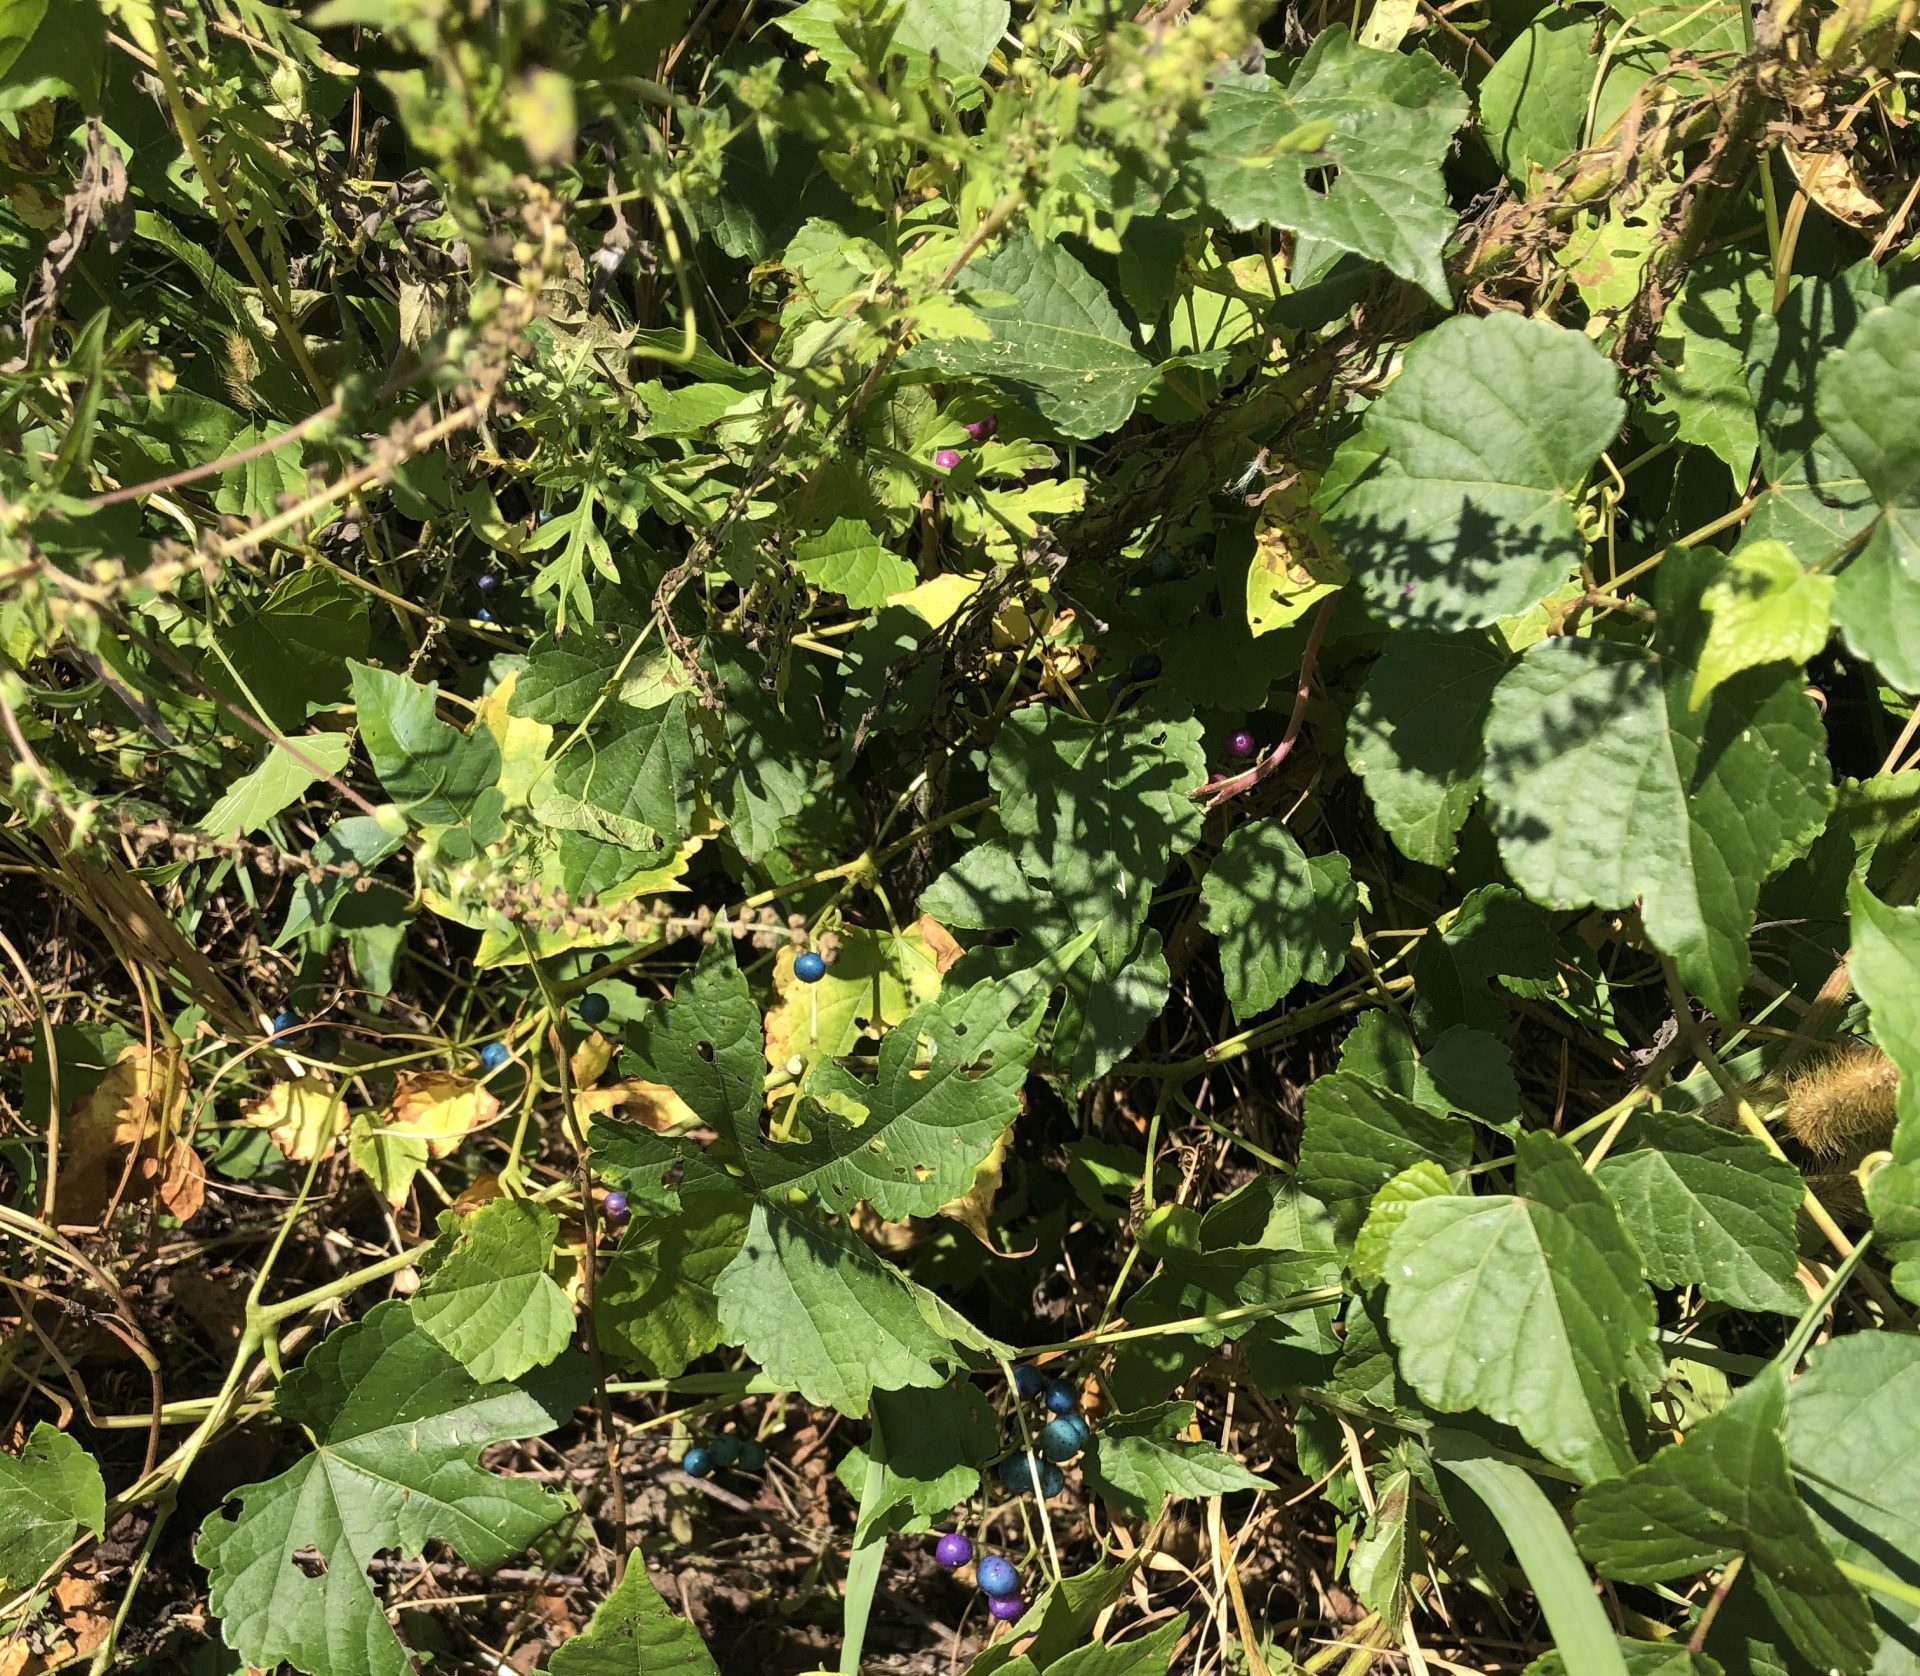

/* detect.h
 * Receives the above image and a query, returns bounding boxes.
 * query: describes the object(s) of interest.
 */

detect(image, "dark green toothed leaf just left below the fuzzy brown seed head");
[1594,1112,1807,1315]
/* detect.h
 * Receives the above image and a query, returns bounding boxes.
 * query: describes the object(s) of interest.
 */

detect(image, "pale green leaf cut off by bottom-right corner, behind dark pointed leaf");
[1788,1332,1920,1676]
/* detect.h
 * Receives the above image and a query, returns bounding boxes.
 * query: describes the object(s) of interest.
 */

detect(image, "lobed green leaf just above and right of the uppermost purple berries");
[900,236,1154,438]
